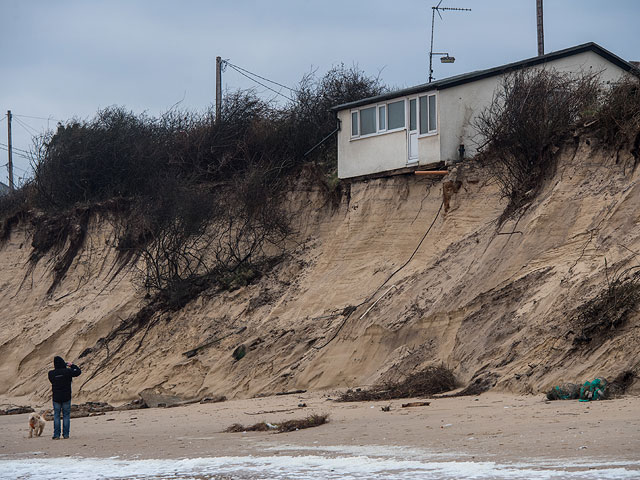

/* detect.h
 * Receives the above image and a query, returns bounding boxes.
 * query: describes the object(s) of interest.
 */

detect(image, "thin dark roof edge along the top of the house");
[331,42,640,111]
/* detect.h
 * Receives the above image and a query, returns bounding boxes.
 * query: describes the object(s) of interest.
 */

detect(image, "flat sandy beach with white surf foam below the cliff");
[0,392,640,478]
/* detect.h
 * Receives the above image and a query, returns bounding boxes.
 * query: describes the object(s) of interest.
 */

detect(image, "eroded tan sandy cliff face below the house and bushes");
[0,137,640,402]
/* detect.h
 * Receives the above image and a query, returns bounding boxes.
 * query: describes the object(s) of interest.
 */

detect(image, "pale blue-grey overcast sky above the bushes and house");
[0,0,640,184]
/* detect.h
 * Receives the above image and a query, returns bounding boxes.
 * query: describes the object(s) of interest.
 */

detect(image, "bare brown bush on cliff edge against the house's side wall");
[475,69,599,220]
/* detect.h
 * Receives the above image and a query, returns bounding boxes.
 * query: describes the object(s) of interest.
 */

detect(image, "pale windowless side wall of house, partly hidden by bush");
[438,52,625,162]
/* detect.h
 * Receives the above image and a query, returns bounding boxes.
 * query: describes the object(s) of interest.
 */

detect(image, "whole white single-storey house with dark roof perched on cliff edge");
[333,43,639,179]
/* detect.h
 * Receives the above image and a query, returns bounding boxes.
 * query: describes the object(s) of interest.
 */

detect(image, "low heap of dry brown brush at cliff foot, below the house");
[337,366,456,402]
